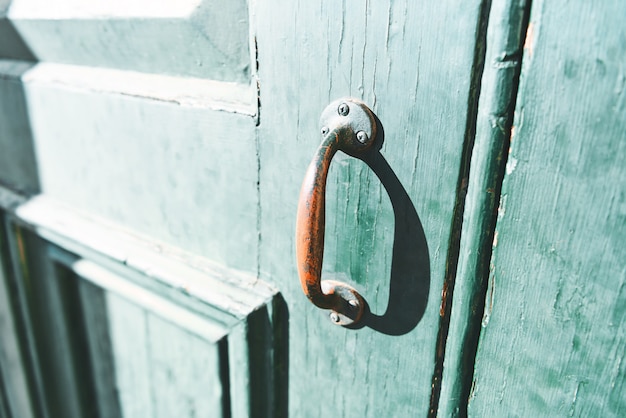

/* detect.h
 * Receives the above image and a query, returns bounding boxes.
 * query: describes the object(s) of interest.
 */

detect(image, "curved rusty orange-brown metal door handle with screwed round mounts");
[296,98,376,326]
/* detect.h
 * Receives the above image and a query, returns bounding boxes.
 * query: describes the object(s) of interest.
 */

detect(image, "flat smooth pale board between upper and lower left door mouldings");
[20,72,258,271]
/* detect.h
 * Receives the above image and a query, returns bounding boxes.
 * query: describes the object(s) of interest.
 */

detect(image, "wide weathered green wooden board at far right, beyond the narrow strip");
[469,0,626,417]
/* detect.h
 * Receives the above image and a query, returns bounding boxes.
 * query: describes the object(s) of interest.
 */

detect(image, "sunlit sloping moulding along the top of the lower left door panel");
[18,195,276,325]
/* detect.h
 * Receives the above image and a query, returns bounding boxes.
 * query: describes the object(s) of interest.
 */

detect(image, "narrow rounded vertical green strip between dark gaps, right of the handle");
[437,0,530,417]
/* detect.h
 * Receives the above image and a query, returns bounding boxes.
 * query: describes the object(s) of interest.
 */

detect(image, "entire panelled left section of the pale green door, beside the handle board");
[0,0,286,418]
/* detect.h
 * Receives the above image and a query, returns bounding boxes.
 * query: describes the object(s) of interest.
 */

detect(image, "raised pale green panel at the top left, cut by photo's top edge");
[9,0,252,84]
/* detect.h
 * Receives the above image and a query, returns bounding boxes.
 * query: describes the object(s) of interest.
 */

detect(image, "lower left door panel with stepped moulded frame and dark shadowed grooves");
[0,197,286,417]
